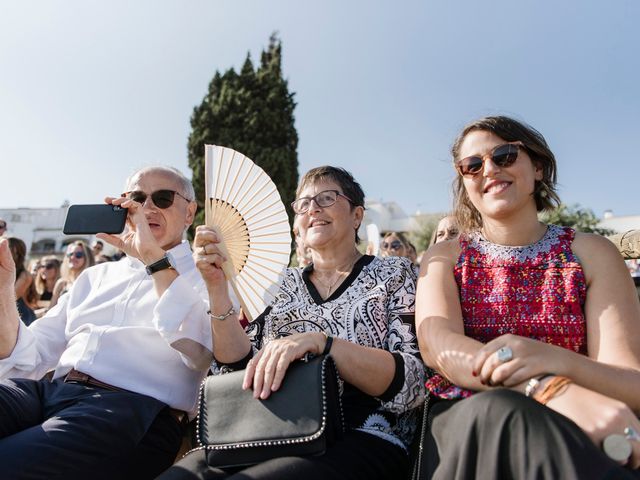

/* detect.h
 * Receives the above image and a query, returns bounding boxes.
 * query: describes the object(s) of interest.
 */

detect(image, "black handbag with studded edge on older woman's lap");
[190,355,344,468]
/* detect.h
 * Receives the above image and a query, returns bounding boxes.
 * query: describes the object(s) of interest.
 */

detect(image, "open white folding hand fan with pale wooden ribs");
[205,145,291,321]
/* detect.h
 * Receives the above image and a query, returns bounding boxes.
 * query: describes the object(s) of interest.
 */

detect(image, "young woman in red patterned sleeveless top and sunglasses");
[416,117,640,479]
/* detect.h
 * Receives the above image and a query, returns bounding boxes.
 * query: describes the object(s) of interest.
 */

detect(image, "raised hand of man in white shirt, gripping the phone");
[96,197,164,264]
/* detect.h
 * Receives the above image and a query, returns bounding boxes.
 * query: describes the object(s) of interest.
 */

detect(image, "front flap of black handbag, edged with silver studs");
[198,357,327,448]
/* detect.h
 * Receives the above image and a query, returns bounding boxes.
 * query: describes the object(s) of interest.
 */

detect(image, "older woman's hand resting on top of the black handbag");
[242,332,326,400]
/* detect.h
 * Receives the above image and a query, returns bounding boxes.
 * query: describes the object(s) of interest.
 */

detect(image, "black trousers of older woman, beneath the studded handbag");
[158,431,409,480]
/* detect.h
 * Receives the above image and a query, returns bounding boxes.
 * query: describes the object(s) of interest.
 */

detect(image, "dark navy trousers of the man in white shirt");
[0,379,182,480]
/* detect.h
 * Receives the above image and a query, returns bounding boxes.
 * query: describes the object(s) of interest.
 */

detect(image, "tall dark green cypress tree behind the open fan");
[188,34,298,236]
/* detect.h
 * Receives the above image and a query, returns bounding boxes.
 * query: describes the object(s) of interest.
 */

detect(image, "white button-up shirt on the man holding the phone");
[0,242,212,412]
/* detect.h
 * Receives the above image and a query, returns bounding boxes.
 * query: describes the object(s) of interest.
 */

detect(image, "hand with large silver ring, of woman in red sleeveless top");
[472,334,570,387]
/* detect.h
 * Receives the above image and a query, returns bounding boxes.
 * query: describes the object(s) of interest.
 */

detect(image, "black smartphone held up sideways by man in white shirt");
[62,203,127,235]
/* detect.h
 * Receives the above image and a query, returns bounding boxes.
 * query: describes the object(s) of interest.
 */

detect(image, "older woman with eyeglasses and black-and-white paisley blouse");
[160,167,424,480]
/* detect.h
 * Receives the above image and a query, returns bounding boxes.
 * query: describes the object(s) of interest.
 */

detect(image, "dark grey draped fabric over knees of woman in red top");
[421,389,639,480]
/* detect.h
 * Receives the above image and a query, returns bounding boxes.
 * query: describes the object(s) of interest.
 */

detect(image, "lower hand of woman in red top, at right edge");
[547,383,640,469]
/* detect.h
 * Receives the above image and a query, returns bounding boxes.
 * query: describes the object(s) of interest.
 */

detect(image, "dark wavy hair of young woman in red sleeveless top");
[451,116,560,231]
